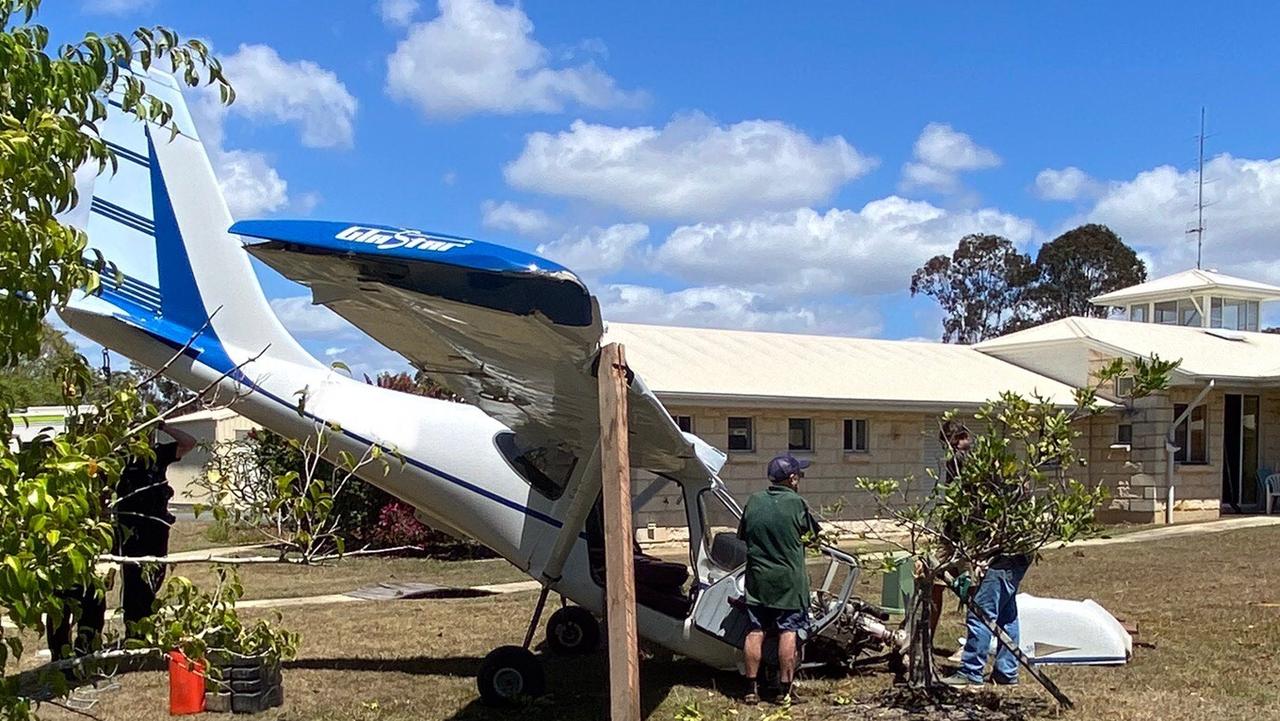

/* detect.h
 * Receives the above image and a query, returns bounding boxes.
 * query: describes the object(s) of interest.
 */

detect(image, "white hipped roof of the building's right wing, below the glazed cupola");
[974,318,1280,382]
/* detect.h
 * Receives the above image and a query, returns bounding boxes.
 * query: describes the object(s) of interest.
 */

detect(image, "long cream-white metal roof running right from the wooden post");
[604,323,1090,409]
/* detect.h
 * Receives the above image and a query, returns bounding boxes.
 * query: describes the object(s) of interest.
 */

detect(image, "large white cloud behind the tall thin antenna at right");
[1073,154,1280,283]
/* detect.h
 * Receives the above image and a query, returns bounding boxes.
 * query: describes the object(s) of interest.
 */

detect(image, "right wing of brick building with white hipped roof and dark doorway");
[978,318,1280,523]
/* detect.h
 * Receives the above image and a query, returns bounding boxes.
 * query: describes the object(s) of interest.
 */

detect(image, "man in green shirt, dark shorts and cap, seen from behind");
[737,453,818,704]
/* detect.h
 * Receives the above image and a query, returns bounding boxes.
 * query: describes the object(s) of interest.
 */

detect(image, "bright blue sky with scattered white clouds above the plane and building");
[40,0,1280,369]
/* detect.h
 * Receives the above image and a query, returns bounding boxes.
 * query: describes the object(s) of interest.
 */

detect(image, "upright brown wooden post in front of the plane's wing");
[598,343,640,721]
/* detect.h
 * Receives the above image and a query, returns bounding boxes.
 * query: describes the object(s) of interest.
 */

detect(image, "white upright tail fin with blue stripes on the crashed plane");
[67,70,315,370]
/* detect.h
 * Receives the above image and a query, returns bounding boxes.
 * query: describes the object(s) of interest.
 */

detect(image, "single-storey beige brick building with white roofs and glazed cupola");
[607,270,1280,539]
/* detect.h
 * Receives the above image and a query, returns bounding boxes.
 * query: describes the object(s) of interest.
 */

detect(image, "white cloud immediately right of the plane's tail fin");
[191,45,356,218]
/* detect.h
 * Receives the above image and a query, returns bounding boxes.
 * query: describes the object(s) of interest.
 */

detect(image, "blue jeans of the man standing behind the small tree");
[942,555,1032,686]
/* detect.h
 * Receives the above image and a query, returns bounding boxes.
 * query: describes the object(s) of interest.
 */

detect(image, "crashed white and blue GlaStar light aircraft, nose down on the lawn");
[61,72,1131,701]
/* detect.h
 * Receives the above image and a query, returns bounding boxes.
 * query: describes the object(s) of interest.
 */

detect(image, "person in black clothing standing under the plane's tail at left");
[115,423,196,638]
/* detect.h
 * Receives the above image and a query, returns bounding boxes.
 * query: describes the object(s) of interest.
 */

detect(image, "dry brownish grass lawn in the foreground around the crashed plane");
[35,528,1280,721]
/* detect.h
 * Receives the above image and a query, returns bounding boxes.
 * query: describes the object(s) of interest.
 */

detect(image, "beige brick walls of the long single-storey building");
[635,384,1280,529]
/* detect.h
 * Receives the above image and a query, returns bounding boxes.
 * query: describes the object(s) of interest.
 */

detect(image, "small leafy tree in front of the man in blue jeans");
[856,357,1178,685]
